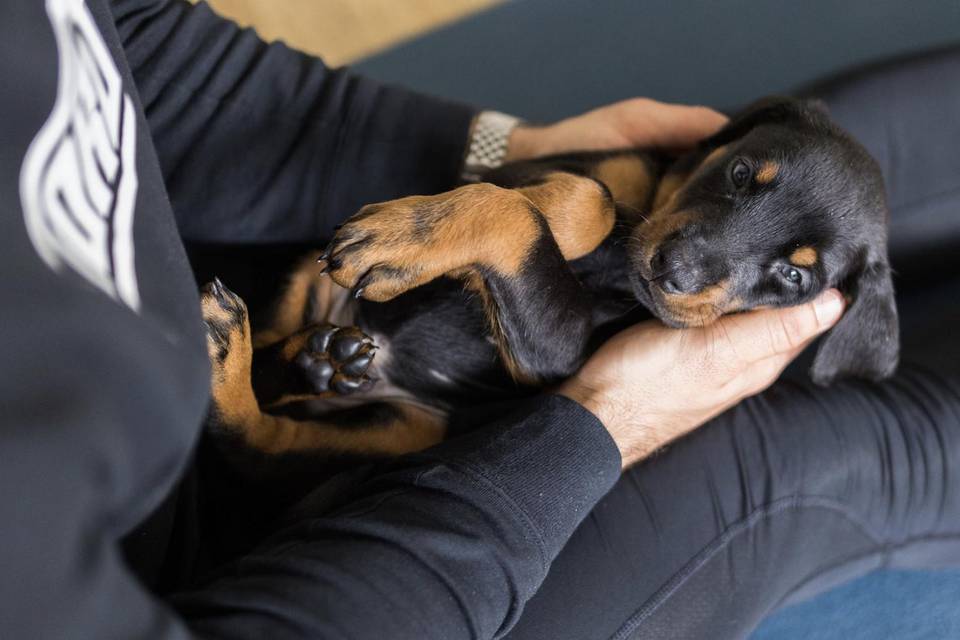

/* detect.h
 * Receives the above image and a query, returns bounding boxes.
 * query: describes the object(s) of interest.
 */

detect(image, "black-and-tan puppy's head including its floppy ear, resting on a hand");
[631,98,899,384]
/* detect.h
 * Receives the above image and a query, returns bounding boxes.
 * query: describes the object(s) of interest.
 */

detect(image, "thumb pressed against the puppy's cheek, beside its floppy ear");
[710,289,844,363]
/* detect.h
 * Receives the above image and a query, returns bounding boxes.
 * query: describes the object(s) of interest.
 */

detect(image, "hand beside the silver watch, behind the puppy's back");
[505,98,727,162]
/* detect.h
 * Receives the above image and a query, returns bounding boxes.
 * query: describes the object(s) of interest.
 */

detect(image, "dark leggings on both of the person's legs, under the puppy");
[509,49,960,640]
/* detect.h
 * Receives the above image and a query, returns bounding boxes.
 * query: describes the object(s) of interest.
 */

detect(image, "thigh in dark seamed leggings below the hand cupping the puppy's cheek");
[510,368,960,639]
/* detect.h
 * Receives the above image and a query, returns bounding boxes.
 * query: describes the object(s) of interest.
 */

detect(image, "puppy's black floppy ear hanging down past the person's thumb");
[810,259,900,385]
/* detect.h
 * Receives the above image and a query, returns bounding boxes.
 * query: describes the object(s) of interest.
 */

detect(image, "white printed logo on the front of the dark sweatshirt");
[20,0,140,310]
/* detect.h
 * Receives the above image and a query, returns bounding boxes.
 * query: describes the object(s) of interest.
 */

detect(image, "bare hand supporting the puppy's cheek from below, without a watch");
[558,289,844,468]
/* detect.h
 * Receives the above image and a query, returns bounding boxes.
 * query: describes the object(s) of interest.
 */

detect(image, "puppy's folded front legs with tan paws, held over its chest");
[327,171,615,383]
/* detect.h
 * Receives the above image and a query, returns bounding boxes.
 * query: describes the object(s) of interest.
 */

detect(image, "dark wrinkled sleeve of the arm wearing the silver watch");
[112,0,474,242]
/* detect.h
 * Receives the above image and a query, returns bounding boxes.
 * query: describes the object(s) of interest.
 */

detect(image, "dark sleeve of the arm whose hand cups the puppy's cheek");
[173,396,620,640]
